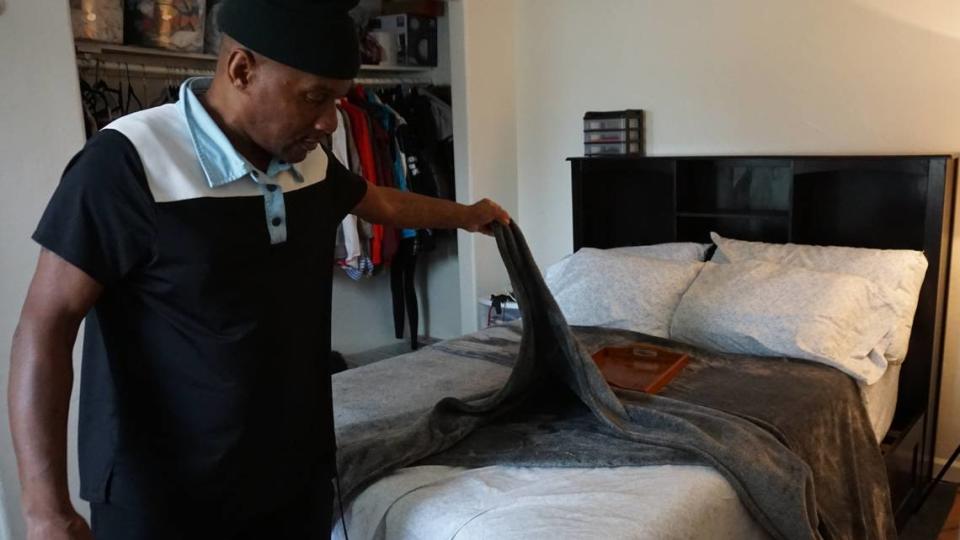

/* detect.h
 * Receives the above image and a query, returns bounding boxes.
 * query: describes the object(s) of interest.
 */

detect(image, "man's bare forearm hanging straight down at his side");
[7,321,79,516]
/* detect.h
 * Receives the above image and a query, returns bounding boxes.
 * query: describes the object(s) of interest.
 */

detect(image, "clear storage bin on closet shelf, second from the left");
[124,0,207,53]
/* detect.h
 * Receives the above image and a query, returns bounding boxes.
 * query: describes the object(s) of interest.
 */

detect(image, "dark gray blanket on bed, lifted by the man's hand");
[334,221,896,539]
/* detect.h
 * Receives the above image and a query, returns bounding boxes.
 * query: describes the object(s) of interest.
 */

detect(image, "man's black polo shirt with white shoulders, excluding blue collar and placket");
[34,83,366,513]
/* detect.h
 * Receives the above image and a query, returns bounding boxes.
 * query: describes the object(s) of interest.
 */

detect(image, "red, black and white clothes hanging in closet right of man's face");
[331,85,455,349]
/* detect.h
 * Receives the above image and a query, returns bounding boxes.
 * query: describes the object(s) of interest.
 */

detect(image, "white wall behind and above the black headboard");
[516,0,960,480]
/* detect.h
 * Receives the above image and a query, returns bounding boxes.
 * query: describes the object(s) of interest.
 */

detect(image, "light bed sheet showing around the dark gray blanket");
[334,323,899,539]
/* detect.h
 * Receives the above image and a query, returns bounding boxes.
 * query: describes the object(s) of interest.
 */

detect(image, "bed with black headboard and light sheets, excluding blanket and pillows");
[334,156,954,538]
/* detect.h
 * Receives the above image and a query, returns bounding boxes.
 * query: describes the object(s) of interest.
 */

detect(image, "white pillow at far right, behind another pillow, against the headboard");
[710,233,927,363]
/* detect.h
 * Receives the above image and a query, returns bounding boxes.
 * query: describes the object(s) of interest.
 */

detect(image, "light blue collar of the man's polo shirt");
[177,77,303,188]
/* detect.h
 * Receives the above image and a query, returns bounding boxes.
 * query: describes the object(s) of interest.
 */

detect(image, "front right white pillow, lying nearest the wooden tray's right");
[670,260,897,384]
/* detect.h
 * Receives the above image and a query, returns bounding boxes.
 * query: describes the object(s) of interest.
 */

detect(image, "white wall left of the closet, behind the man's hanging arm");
[0,0,86,538]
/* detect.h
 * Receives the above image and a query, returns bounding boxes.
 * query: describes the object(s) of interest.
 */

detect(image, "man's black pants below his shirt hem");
[90,481,333,540]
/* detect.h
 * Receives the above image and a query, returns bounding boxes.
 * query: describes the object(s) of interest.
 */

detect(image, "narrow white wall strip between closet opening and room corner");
[447,0,519,332]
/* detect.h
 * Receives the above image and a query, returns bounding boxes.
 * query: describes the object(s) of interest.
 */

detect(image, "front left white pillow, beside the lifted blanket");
[545,248,703,337]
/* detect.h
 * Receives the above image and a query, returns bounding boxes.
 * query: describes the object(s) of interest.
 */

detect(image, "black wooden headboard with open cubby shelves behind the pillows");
[570,155,957,523]
